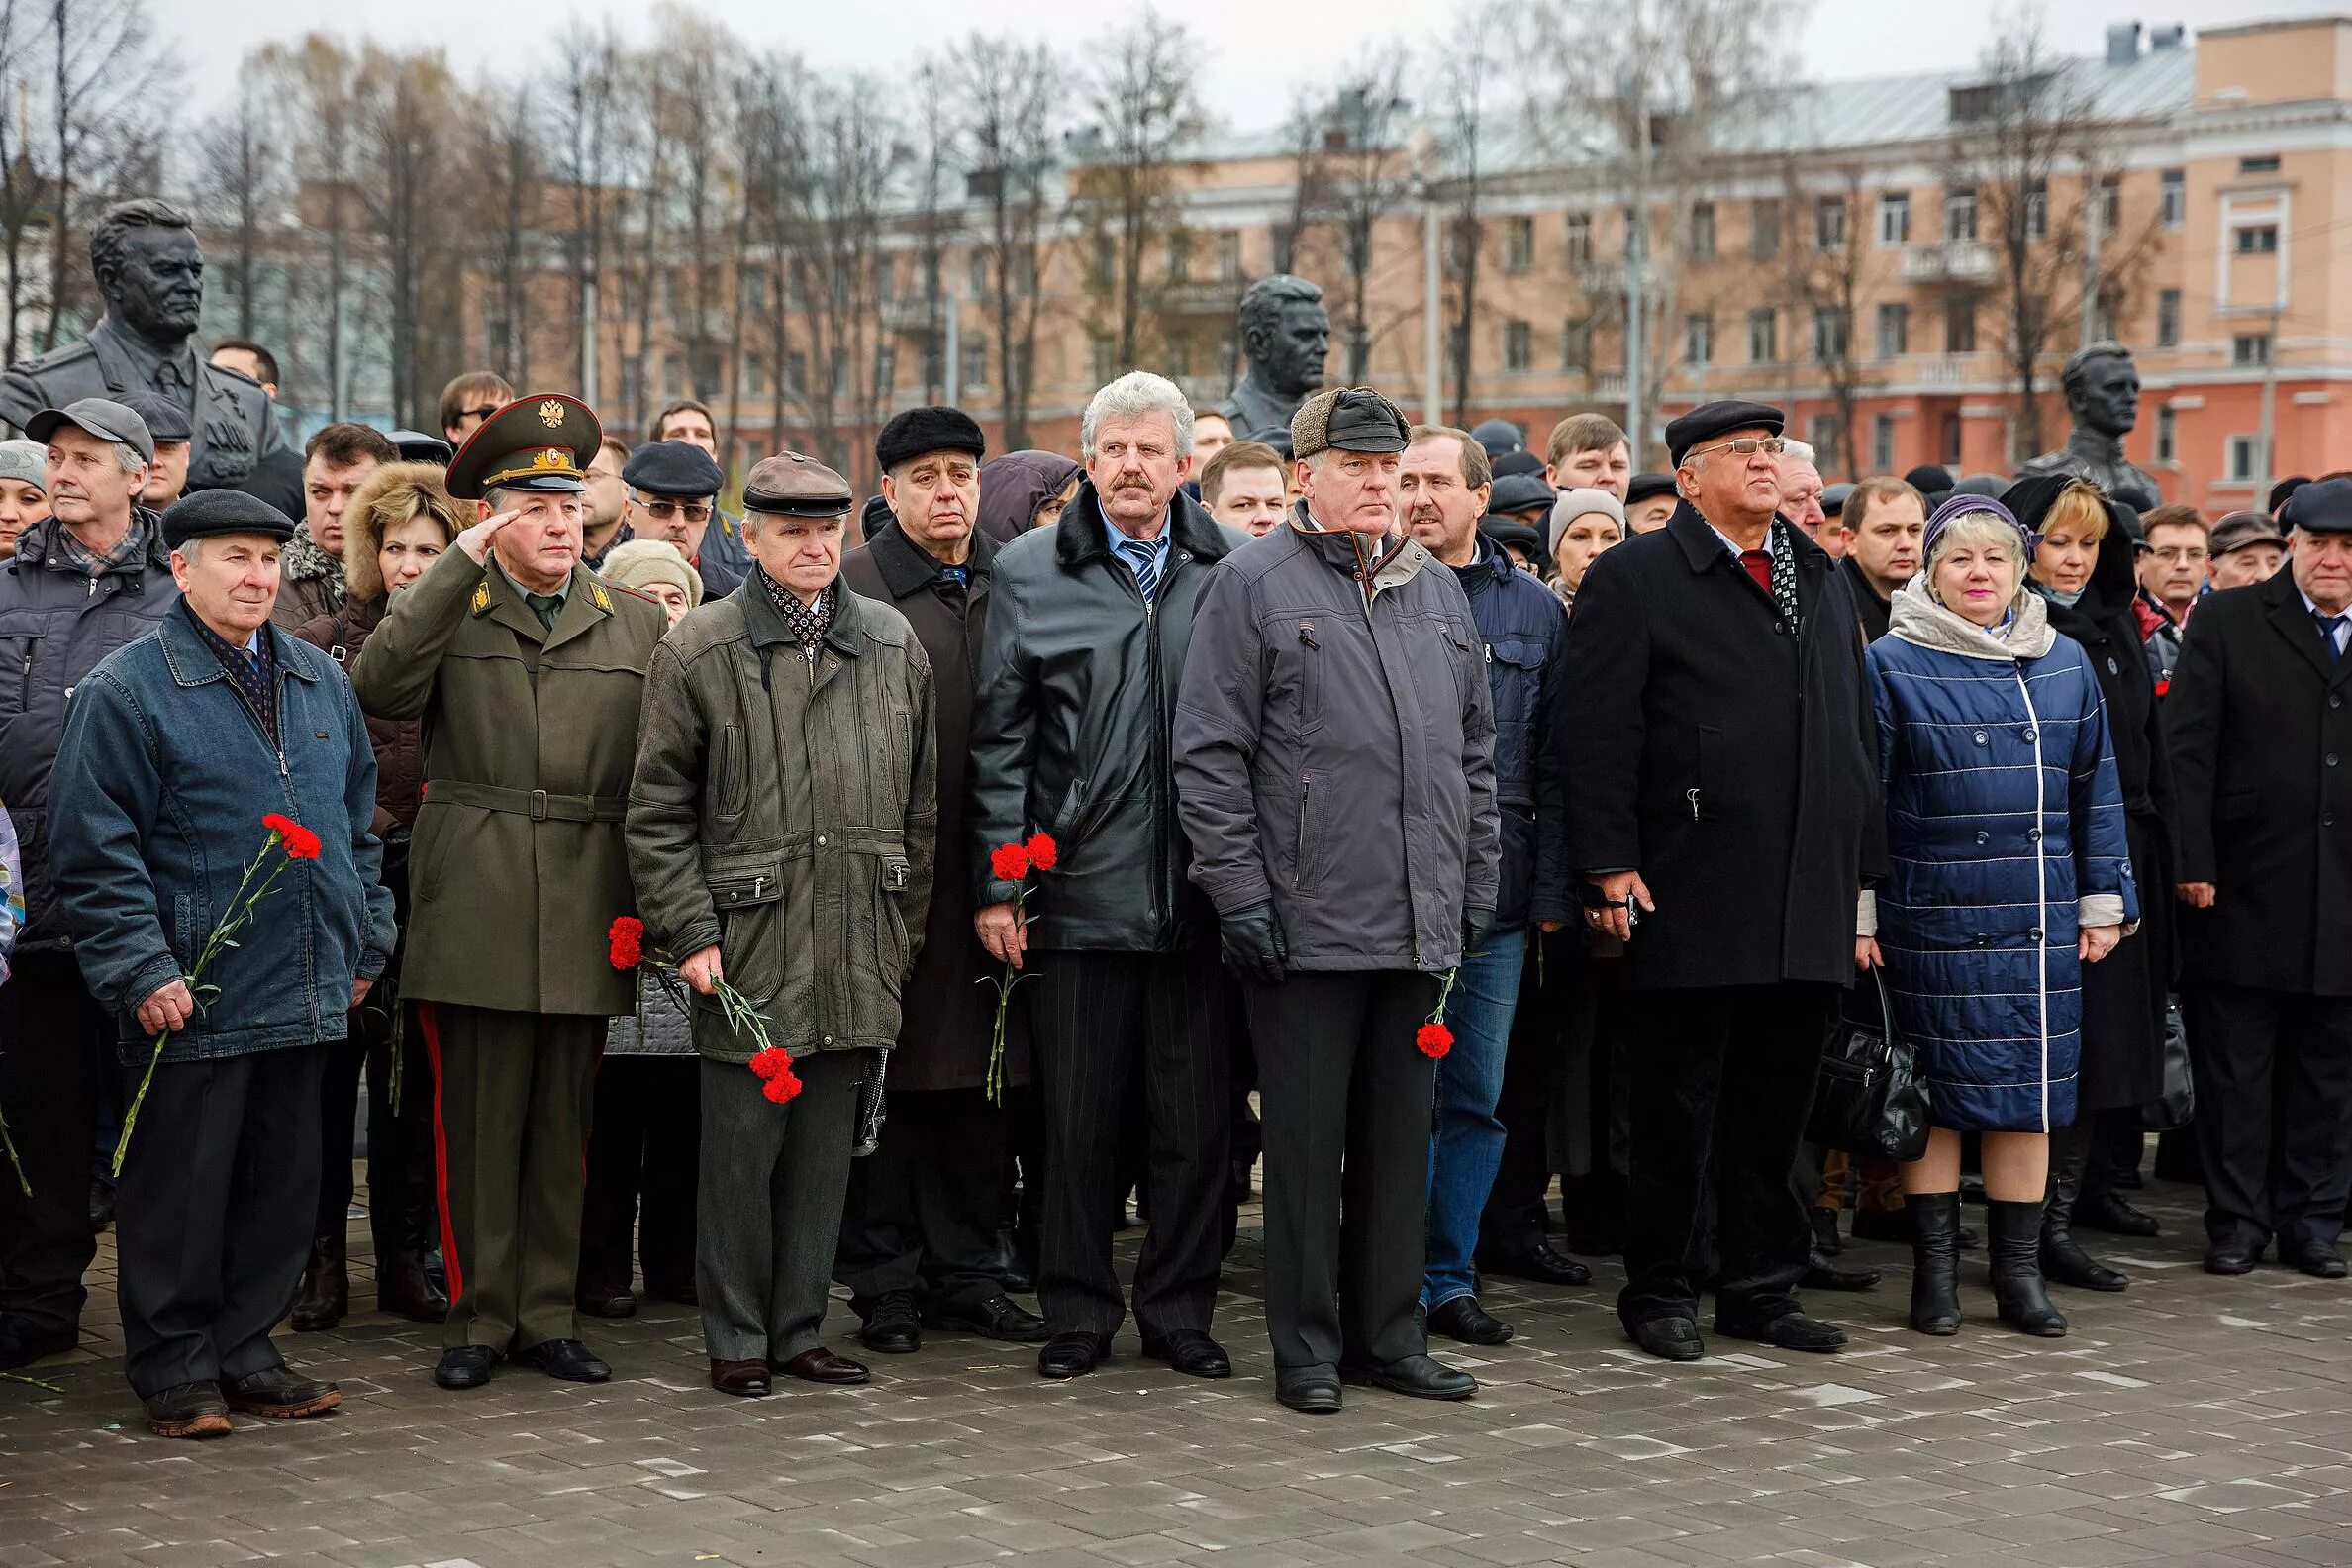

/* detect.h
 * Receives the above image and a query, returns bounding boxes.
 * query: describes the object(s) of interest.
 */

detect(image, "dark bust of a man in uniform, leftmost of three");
[0,197,277,489]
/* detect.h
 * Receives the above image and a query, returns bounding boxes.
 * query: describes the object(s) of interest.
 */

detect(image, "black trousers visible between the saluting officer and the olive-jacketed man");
[578,1055,703,1300]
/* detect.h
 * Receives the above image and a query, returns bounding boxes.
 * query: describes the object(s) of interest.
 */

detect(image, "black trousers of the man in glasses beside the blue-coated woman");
[1618,985,1837,1328]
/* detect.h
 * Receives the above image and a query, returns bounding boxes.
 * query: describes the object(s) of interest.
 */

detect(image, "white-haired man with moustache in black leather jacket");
[964,371,1246,1378]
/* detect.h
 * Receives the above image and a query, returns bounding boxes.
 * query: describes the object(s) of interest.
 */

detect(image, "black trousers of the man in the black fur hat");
[833,1089,1009,1317]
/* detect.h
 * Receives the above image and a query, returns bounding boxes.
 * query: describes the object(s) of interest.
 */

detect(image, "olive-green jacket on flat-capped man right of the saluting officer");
[626,578,938,1062]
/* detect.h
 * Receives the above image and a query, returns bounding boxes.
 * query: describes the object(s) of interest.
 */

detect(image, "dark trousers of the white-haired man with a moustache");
[1028,949,1232,1335]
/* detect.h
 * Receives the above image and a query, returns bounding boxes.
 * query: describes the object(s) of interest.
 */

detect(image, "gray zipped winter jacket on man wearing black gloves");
[1174,517,1499,973]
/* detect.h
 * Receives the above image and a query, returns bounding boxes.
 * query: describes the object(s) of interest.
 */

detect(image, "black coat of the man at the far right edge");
[2164,569,2352,997]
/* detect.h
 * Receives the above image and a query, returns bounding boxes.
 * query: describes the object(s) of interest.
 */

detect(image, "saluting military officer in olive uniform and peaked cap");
[350,393,668,1390]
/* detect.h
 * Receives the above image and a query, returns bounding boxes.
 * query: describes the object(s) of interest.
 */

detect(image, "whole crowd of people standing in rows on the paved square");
[0,343,2352,1436]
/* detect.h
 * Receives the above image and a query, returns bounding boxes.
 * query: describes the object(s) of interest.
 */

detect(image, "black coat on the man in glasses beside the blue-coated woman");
[1557,503,1887,990]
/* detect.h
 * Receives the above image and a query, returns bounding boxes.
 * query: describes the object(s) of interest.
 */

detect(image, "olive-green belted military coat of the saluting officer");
[350,550,668,1016]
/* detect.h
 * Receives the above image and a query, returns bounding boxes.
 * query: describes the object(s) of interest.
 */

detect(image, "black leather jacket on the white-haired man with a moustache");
[967,482,1249,952]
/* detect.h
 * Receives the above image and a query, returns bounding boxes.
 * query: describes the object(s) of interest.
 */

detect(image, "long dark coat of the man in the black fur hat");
[842,527,1028,1091]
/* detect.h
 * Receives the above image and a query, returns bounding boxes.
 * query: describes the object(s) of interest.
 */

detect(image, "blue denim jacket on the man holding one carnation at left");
[51,602,393,1062]
